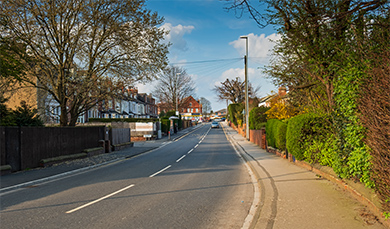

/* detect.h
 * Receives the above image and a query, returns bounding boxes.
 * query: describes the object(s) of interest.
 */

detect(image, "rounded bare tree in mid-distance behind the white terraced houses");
[153,66,195,110]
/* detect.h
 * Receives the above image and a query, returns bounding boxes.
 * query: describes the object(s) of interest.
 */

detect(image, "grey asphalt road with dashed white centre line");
[0,124,253,228]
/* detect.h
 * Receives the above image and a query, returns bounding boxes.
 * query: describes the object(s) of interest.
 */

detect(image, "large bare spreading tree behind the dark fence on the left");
[0,0,167,126]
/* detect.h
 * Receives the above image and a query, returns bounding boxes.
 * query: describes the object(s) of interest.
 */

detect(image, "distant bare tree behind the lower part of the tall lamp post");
[213,77,260,103]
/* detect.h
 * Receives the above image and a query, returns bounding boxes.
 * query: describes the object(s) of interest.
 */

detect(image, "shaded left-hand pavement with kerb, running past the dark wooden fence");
[0,125,200,193]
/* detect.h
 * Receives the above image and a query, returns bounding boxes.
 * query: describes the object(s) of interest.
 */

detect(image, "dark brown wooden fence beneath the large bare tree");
[0,126,107,171]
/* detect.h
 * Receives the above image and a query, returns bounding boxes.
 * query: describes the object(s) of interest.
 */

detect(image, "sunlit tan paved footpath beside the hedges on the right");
[221,122,387,229]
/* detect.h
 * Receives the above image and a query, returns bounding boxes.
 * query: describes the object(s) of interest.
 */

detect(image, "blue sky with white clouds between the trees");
[137,0,279,111]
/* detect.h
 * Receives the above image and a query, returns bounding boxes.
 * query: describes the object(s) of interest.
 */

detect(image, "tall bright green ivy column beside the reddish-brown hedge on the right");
[333,64,374,187]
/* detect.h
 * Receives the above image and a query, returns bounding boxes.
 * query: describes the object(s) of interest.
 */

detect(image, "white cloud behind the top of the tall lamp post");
[229,33,280,58]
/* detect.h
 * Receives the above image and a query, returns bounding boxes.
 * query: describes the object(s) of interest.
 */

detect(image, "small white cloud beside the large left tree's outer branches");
[161,23,195,51]
